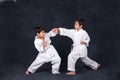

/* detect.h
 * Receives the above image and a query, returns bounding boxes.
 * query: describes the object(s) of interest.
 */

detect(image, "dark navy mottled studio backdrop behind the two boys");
[0,0,120,80]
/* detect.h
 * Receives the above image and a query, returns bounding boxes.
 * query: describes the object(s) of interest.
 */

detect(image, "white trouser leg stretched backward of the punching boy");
[80,57,100,70]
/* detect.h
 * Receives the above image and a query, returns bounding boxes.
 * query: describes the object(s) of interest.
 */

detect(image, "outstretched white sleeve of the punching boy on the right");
[59,28,74,38]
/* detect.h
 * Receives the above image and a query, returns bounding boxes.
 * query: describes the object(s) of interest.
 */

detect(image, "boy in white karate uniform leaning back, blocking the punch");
[25,26,61,75]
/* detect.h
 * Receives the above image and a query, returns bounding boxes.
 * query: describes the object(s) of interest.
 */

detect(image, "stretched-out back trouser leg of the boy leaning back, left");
[28,55,47,73]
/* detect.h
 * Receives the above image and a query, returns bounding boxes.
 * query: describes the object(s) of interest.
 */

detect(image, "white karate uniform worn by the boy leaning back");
[28,31,61,73]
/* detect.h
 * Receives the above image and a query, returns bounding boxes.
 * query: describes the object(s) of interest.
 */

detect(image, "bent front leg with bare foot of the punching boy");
[67,51,80,75]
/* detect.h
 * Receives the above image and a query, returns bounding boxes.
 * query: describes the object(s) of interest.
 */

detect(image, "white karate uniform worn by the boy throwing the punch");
[59,28,98,71]
